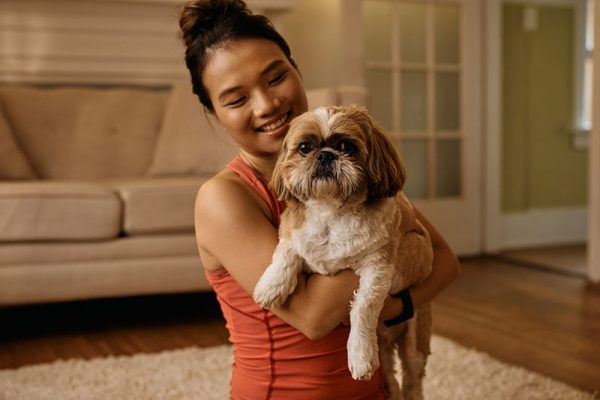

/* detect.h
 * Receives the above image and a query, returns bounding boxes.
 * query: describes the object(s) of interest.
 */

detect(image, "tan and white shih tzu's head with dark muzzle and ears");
[271,106,405,203]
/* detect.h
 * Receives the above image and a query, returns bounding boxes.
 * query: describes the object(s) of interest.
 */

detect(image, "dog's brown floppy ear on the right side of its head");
[367,109,406,200]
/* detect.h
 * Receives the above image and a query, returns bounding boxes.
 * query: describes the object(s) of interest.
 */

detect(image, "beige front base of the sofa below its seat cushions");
[0,253,211,306]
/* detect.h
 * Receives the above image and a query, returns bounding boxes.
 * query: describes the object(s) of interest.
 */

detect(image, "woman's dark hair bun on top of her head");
[179,0,252,46]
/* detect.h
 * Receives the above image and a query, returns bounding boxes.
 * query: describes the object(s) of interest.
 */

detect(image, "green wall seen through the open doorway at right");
[502,4,588,212]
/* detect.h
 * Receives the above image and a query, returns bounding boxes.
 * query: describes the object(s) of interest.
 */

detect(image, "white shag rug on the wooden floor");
[0,336,600,400]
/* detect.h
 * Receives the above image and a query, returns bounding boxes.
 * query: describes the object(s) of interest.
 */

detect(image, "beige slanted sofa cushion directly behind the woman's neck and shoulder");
[147,81,239,177]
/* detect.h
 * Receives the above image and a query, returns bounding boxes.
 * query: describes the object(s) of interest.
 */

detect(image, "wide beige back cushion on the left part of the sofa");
[0,87,167,180]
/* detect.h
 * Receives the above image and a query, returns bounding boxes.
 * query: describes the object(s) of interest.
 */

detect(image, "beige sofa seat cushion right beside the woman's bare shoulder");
[110,177,207,235]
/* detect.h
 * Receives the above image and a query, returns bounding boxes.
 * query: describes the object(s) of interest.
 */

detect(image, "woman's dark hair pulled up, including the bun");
[179,0,296,112]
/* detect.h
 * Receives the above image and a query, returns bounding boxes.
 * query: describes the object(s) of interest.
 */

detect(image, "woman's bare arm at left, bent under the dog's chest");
[195,174,358,339]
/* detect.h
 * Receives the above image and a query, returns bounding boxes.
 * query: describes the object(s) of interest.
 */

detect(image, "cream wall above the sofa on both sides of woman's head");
[0,0,344,88]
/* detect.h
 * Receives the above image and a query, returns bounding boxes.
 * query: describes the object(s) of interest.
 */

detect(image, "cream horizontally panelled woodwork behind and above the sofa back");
[0,0,295,86]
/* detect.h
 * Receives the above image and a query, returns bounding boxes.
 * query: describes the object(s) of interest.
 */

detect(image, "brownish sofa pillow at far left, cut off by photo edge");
[0,107,36,180]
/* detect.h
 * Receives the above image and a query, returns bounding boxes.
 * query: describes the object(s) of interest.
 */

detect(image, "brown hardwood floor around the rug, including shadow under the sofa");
[0,258,600,391]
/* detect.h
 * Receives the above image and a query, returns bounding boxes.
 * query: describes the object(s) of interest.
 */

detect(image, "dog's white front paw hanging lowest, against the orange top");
[348,330,379,380]
